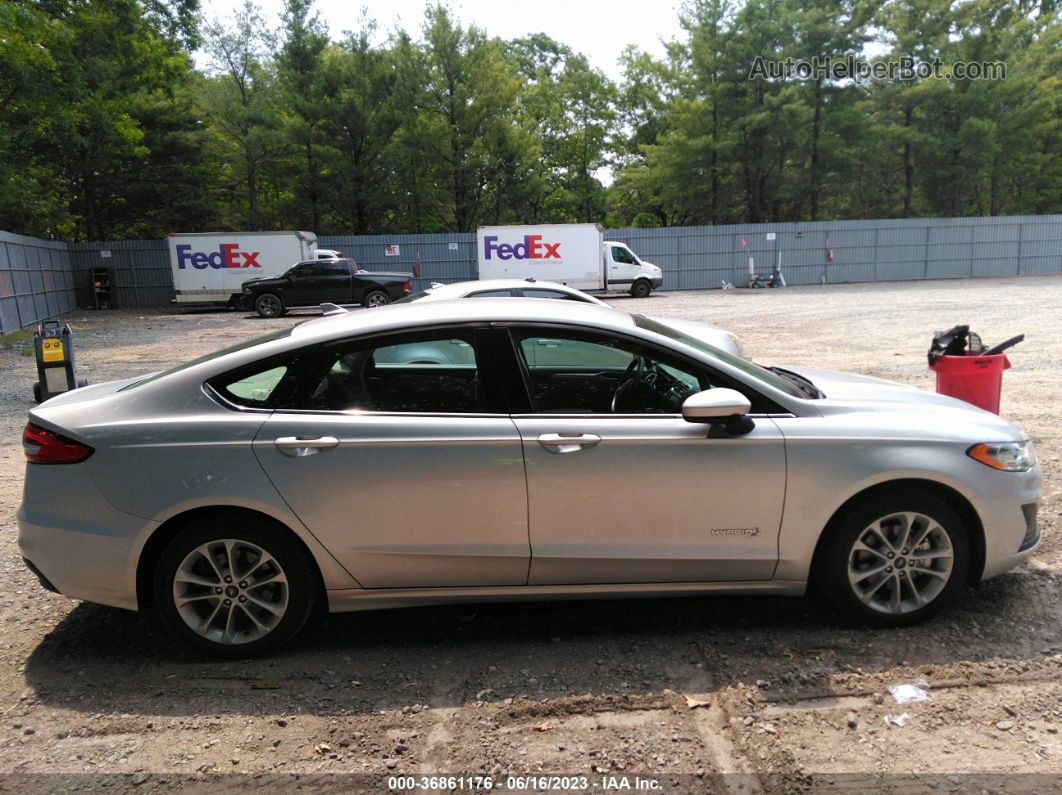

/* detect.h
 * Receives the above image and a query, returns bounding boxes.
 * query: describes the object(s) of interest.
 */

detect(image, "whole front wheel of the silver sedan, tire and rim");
[820,491,970,626]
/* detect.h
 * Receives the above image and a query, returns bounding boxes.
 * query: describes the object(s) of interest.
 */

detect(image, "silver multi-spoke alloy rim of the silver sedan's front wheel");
[847,512,955,616]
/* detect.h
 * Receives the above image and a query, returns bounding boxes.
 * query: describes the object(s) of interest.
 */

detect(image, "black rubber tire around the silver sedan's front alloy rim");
[815,490,970,626]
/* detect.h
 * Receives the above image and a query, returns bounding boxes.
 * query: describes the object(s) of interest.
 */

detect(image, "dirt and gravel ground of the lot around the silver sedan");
[0,277,1062,793]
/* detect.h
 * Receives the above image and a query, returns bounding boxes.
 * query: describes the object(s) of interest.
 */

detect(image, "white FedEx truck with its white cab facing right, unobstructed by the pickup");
[476,224,664,298]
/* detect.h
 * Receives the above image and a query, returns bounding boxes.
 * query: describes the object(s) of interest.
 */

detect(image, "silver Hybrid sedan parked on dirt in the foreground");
[18,299,1040,656]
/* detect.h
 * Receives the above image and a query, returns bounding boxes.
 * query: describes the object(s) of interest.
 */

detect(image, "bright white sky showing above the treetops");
[203,0,682,80]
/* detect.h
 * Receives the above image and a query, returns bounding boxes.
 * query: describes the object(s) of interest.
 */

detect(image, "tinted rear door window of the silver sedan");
[293,331,483,414]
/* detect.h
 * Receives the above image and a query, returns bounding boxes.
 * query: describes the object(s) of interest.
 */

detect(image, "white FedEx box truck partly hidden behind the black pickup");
[170,231,339,304]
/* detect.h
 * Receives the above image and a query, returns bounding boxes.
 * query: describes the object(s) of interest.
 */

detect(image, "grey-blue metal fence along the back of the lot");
[0,214,1062,333]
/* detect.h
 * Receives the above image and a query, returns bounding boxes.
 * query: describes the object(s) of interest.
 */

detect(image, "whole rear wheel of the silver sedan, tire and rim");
[154,518,319,657]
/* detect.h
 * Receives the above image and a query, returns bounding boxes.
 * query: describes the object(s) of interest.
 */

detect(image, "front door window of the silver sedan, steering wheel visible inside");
[517,332,708,414]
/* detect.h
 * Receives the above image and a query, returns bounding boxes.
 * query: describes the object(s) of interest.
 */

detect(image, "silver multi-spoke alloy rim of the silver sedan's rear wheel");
[173,538,289,645]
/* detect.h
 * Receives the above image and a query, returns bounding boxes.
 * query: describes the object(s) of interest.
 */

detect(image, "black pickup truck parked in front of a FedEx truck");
[239,259,413,317]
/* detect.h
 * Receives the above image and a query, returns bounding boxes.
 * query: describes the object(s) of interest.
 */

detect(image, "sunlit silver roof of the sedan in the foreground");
[291,298,635,340]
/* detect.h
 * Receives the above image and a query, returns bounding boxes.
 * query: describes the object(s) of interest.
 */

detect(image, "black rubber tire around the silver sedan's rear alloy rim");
[153,515,321,658]
